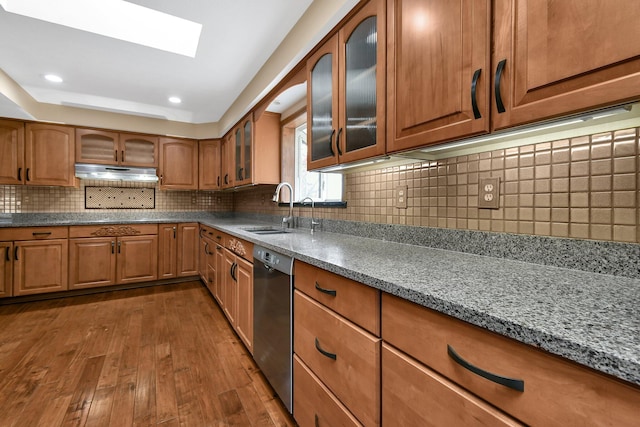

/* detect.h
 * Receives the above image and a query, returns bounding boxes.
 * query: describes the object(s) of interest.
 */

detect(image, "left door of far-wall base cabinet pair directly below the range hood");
[69,237,116,289]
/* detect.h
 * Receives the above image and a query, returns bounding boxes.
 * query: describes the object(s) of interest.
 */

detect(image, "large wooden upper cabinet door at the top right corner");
[492,0,640,129]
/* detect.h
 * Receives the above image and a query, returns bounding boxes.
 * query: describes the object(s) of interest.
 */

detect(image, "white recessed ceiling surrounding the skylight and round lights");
[0,0,322,123]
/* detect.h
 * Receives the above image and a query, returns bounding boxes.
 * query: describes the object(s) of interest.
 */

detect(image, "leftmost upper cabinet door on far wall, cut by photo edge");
[0,120,25,185]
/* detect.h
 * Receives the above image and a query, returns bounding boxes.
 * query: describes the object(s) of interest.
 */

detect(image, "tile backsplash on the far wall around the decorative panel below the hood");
[0,180,233,213]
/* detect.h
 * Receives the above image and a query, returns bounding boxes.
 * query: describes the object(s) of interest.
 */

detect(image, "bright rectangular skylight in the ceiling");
[0,0,202,58]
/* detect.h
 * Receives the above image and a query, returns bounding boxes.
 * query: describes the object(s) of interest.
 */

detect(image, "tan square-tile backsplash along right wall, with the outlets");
[234,128,640,242]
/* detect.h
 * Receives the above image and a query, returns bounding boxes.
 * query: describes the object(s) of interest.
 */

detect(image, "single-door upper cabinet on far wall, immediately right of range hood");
[159,138,198,190]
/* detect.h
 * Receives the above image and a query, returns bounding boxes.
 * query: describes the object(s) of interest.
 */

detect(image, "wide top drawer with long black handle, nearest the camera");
[382,294,640,426]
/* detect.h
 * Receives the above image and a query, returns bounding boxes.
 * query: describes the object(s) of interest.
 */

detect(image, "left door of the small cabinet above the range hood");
[76,128,120,165]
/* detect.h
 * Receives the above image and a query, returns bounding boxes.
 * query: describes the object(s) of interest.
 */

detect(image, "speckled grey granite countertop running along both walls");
[0,212,640,385]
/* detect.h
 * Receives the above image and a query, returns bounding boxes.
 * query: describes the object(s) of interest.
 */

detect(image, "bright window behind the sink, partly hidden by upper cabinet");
[294,123,343,202]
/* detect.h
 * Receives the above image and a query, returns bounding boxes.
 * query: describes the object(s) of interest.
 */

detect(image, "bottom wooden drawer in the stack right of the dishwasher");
[293,356,362,427]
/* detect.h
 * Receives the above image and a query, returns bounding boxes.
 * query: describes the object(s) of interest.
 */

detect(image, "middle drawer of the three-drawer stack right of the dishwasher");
[293,290,380,426]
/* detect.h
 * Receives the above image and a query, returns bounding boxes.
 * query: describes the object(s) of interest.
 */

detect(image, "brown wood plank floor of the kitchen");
[0,282,295,427]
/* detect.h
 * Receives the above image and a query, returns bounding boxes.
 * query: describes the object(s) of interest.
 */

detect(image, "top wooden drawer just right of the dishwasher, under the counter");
[294,261,380,336]
